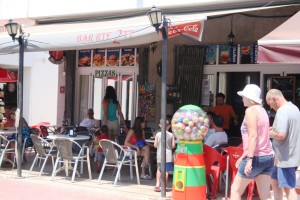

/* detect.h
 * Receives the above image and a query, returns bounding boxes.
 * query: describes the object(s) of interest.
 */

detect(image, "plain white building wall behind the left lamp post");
[0,52,64,125]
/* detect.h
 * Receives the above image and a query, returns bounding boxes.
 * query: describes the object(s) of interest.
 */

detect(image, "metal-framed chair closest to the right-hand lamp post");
[98,139,140,187]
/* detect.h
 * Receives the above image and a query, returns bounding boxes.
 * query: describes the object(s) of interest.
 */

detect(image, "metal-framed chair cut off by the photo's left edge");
[0,135,16,168]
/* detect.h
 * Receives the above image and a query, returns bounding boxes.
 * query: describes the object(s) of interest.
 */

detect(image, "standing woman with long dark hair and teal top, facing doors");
[102,86,127,141]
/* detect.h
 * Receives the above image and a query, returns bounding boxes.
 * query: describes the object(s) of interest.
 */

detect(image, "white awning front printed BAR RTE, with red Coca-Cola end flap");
[0,15,205,53]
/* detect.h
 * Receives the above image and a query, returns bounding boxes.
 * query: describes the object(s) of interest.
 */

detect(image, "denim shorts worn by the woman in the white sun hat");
[238,155,274,179]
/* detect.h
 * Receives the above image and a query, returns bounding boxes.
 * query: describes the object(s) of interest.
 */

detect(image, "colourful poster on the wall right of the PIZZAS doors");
[138,84,156,121]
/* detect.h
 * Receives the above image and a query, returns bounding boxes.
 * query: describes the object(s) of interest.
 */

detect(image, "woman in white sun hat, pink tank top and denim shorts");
[230,84,274,200]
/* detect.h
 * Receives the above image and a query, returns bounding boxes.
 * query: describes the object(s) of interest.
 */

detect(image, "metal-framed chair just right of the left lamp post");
[29,134,55,176]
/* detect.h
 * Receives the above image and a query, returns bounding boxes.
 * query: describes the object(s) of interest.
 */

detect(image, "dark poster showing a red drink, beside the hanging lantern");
[219,45,237,64]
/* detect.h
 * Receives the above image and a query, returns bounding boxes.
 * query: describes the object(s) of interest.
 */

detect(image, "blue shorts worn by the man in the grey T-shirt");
[272,166,297,188]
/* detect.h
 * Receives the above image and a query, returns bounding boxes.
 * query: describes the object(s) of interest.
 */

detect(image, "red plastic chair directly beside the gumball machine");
[203,144,226,198]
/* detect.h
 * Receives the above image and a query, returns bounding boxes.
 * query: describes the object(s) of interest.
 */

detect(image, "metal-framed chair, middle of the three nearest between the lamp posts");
[51,138,92,182]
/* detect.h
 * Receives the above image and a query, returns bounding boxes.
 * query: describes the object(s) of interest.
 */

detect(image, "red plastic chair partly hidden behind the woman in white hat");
[226,146,255,200]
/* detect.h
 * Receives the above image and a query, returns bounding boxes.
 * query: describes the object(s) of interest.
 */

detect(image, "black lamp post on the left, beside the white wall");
[5,19,27,177]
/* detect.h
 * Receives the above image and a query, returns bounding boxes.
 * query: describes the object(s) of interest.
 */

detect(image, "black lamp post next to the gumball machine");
[147,6,168,197]
